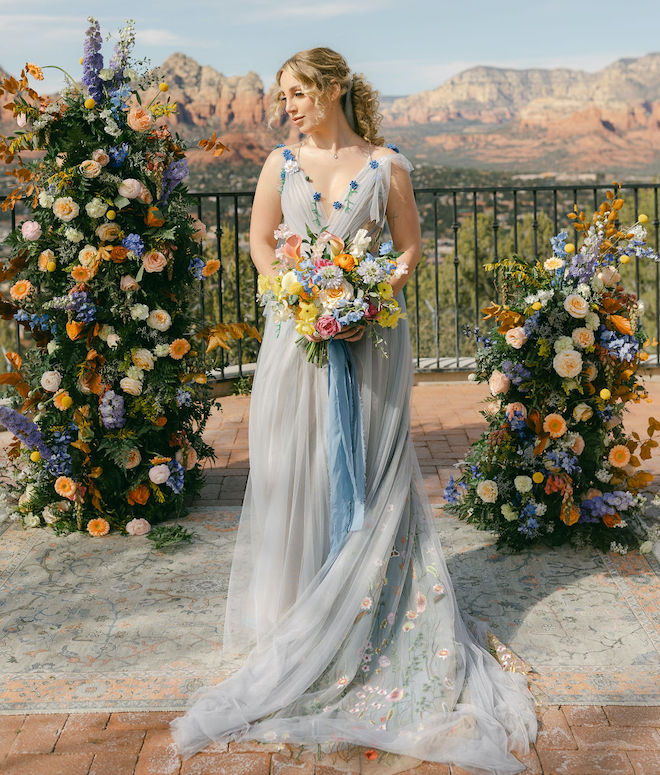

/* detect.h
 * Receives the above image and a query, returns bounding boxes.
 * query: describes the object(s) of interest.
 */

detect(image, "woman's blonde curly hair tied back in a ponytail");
[269,47,385,145]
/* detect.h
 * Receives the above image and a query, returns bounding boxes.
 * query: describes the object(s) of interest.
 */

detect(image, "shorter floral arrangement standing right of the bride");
[445,189,660,551]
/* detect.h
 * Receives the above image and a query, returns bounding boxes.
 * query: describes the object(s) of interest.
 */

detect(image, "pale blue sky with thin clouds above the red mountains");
[0,0,660,96]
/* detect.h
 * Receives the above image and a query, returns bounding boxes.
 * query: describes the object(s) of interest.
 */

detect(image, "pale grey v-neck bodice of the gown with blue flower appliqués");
[281,148,413,244]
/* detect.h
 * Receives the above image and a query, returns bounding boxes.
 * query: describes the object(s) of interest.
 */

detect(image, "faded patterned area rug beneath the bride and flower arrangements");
[0,508,660,713]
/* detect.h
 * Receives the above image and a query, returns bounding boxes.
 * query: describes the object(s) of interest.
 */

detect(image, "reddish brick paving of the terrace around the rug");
[0,377,660,775]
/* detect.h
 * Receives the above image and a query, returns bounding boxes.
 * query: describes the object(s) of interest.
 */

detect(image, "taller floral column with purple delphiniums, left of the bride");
[0,17,258,536]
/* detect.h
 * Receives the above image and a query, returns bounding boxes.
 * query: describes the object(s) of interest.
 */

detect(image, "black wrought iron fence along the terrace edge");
[0,183,660,379]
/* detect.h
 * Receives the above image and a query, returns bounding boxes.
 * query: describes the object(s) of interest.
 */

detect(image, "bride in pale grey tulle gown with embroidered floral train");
[172,48,536,773]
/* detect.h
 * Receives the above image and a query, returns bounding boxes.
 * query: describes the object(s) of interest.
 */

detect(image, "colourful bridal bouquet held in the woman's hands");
[257,224,408,365]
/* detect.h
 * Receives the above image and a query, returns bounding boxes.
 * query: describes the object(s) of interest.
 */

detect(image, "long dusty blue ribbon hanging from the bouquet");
[326,339,365,559]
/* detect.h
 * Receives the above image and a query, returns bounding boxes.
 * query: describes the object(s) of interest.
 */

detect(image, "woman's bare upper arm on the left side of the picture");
[250,148,282,275]
